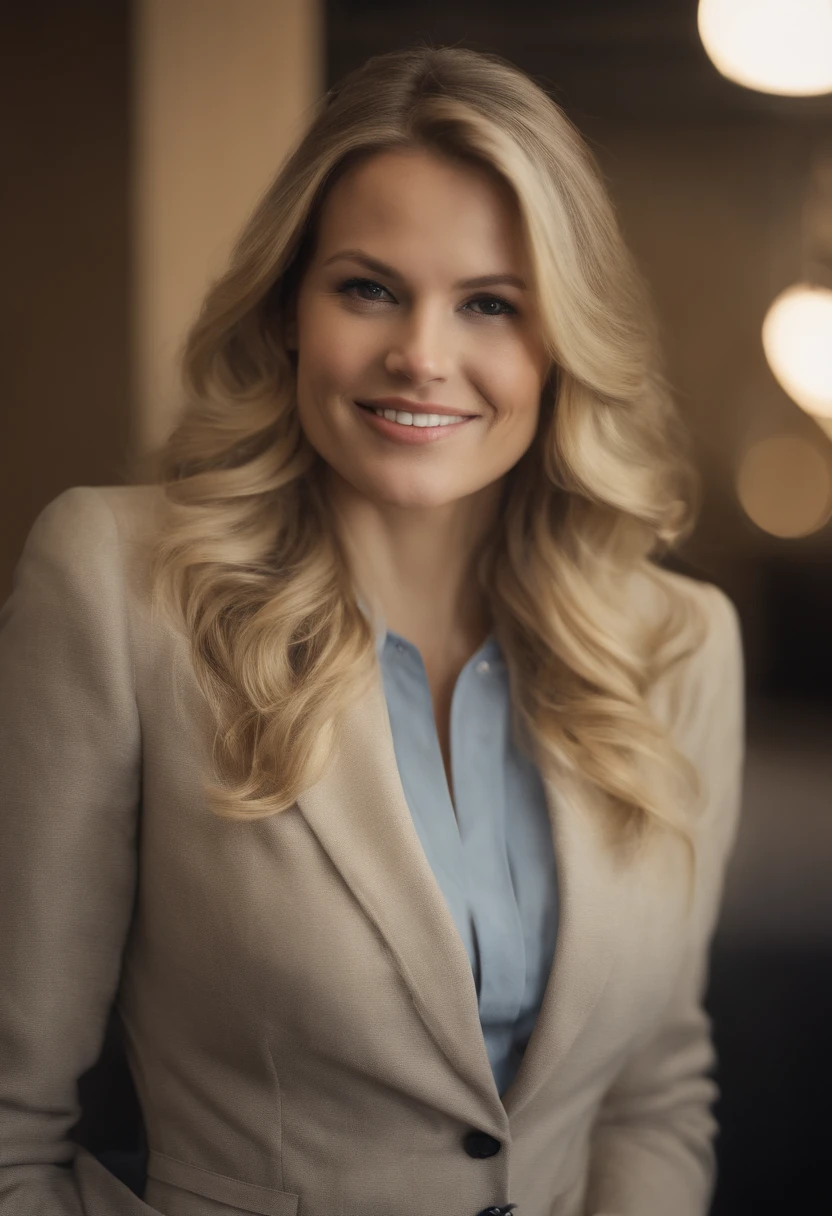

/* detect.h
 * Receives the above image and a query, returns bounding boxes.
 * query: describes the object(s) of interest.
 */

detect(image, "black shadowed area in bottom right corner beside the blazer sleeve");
[707,941,832,1216]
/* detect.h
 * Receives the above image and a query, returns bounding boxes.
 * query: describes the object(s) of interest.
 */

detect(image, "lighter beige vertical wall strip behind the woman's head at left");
[133,0,324,455]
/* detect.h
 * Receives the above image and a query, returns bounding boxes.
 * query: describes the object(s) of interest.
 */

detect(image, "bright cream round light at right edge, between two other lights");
[763,283,832,418]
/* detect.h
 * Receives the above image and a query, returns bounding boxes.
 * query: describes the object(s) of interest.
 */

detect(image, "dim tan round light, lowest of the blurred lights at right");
[737,435,832,539]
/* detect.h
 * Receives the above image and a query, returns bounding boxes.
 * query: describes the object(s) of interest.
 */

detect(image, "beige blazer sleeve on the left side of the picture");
[0,488,144,1216]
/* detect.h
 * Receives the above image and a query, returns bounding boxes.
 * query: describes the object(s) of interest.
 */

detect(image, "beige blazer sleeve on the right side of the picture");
[585,585,744,1216]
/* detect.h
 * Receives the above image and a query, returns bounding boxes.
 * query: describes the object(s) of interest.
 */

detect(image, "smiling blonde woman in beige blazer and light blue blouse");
[0,47,742,1216]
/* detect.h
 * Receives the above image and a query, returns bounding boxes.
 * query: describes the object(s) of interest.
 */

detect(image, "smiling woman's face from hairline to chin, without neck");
[288,151,549,507]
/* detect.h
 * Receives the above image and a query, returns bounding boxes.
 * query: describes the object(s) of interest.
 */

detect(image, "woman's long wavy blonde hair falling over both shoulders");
[145,46,699,843]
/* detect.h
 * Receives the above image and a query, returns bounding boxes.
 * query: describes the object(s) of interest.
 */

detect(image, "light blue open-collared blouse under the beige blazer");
[359,599,558,1094]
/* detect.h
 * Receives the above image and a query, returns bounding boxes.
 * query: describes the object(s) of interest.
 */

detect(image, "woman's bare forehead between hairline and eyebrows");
[316,150,524,272]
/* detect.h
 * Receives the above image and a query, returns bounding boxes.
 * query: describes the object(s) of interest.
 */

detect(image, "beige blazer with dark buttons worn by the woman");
[0,486,742,1216]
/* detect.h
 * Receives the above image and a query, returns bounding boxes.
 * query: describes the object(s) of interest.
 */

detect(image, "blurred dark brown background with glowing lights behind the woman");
[0,0,832,1216]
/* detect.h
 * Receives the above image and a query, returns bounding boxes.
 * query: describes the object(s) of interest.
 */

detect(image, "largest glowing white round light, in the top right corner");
[697,0,832,97]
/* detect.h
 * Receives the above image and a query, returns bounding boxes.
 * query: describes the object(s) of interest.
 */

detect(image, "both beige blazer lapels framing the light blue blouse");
[291,674,624,1125]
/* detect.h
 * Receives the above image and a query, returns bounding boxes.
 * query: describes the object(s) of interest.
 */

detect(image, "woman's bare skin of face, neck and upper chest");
[287,150,550,797]
